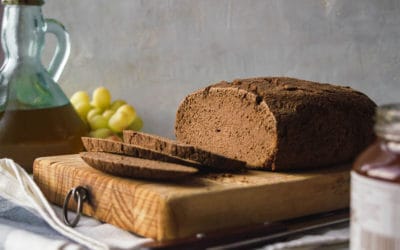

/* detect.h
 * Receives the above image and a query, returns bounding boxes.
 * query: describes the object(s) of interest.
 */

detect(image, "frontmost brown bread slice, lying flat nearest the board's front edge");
[80,152,198,180]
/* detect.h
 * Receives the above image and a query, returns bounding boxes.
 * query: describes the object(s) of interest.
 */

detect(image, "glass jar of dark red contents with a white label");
[350,104,400,250]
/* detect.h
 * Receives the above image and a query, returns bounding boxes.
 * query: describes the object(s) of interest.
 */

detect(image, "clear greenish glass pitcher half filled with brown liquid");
[0,0,88,172]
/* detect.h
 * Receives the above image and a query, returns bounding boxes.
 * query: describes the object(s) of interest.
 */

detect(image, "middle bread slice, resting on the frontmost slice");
[82,137,202,168]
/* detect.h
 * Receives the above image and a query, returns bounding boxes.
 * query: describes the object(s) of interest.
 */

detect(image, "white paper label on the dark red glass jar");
[350,171,400,250]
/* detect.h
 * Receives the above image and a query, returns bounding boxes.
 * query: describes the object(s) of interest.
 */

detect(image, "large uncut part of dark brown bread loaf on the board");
[175,77,376,170]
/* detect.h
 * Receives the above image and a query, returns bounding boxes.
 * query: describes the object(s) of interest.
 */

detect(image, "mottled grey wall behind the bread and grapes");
[43,0,400,138]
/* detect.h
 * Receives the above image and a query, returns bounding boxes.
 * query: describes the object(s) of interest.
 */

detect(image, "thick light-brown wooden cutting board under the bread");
[33,155,350,240]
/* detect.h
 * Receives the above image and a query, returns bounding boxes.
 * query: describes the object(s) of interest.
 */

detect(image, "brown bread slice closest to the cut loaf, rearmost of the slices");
[123,130,246,171]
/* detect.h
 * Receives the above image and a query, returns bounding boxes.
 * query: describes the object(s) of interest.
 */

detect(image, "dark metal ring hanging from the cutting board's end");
[63,186,88,227]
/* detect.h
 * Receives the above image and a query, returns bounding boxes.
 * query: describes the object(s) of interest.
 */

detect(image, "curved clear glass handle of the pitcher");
[45,19,71,82]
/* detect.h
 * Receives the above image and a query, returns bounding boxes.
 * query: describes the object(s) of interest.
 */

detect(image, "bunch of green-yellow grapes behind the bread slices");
[70,87,143,138]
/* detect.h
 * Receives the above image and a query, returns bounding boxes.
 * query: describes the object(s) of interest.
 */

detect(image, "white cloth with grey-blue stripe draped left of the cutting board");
[0,159,152,249]
